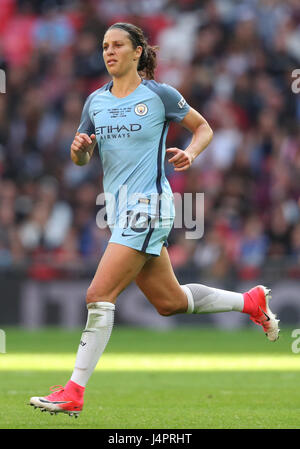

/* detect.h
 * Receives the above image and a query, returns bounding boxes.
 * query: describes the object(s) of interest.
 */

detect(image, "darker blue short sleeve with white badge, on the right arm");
[160,84,190,122]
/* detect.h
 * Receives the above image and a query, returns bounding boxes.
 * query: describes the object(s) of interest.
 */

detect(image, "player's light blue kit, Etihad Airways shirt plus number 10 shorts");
[78,80,190,255]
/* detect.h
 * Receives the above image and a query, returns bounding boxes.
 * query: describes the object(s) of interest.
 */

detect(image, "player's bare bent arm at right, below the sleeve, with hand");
[166,108,213,171]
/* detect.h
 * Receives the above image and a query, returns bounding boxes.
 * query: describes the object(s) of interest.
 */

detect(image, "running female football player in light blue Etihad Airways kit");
[30,23,279,417]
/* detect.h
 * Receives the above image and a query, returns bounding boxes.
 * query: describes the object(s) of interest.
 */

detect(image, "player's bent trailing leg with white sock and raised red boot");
[135,248,279,341]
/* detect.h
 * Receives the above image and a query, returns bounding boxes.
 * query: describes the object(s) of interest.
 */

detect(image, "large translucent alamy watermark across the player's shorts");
[96,185,204,239]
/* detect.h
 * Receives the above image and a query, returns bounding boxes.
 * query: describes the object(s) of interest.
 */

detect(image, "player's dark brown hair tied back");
[107,22,158,79]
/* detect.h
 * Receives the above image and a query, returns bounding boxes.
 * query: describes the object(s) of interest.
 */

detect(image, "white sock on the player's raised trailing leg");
[181,284,244,313]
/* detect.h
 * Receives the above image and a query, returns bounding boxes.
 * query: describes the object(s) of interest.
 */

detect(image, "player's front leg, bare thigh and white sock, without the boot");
[71,243,150,387]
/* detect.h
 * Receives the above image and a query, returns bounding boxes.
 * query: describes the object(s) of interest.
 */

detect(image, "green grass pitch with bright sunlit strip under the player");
[0,326,300,429]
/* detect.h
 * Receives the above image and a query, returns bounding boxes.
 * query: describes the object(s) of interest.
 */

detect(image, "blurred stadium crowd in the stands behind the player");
[0,0,300,279]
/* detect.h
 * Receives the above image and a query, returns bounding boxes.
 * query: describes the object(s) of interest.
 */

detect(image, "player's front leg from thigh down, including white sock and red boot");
[30,243,151,417]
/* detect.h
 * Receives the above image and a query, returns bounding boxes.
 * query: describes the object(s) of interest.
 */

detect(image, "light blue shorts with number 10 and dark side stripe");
[109,192,175,256]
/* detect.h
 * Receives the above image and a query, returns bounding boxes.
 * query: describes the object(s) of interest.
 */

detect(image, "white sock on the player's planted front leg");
[71,302,115,387]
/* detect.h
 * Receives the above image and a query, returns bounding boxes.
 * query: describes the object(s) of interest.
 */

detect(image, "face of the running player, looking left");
[103,28,142,77]
